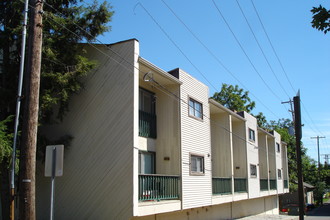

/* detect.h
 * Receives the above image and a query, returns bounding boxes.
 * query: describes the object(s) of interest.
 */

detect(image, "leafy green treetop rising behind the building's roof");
[212,83,255,112]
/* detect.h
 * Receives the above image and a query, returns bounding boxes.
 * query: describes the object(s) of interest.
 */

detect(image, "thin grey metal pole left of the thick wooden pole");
[10,0,29,220]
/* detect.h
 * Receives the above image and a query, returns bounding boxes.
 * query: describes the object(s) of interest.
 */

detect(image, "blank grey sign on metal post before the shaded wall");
[45,145,64,220]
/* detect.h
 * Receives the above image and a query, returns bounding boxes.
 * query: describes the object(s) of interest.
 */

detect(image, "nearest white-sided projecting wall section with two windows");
[179,70,212,209]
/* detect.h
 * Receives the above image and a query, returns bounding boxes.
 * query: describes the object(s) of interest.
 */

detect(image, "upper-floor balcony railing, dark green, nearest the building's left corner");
[139,110,157,138]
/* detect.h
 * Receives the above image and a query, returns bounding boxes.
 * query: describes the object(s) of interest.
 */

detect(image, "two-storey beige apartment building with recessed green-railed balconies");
[37,39,288,220]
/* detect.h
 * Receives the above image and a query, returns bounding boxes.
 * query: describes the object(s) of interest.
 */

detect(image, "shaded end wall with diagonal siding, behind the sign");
[37,40,138,219]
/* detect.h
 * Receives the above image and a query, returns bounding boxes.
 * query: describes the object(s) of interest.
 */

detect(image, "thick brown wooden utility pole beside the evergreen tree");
[19,0,43,220]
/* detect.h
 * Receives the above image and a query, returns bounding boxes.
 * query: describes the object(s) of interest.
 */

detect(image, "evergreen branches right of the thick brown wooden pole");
[40,0,113,121]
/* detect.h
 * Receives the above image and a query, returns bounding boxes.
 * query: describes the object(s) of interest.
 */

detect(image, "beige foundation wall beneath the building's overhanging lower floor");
[132,196,279,220]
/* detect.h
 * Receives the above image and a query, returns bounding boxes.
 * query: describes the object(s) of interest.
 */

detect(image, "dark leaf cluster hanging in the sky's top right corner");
[311,5,330,34]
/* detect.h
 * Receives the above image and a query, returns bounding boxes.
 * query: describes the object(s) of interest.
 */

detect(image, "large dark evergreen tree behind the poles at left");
[0,0,113,219]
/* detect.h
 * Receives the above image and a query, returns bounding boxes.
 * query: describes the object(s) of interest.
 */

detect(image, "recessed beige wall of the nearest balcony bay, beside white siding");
[138,79,181,175]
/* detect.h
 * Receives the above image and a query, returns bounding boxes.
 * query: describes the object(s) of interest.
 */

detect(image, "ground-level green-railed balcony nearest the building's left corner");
[139,174,180,201]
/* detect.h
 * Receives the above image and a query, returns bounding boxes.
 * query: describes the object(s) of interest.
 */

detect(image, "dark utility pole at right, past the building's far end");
[293,92,305,220]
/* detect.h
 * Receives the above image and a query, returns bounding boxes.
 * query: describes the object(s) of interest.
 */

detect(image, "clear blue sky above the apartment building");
[91,0,330,163]
